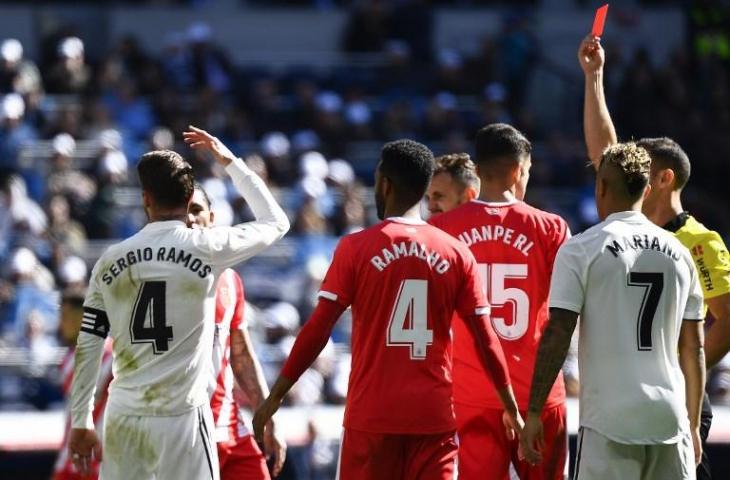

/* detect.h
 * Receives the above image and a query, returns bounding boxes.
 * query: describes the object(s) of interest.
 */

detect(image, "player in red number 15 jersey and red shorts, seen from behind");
[431,123,570,480]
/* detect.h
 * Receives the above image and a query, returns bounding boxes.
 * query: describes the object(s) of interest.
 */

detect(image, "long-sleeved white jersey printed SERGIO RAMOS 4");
[72,160,289,427]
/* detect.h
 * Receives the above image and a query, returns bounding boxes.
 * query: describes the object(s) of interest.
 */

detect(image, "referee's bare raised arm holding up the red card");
[578,35,618,168]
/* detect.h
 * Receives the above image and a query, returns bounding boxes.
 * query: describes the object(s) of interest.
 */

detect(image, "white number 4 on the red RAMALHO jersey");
[387,280,433,360]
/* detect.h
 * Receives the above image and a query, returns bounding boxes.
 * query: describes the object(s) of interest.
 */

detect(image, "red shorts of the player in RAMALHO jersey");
[337,428,456,480]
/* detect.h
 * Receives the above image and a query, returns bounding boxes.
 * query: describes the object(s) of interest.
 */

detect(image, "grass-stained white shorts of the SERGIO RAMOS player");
[99,404,220,480]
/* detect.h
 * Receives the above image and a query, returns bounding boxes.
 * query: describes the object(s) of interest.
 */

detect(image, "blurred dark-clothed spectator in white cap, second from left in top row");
[45,37,91,94]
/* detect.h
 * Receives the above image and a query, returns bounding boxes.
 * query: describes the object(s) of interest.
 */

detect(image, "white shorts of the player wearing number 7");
[574,427,695,480]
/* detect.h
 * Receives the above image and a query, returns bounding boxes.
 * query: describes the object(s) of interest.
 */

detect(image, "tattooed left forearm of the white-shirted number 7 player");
[520,308,578,464]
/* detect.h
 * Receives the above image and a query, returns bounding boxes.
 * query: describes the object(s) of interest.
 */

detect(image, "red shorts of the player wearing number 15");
[454,404,568,480]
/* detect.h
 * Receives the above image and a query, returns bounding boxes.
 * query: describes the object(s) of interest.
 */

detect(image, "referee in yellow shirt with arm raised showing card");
[578,36,730,480]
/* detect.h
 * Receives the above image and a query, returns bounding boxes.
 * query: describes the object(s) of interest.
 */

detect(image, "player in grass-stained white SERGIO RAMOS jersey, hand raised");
[69,127,289,479]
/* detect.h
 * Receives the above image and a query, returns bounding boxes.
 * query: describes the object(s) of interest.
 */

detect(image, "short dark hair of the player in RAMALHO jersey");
[379,140,434,205]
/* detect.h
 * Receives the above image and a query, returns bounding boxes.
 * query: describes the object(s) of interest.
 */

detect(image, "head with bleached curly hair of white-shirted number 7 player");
[599,142,651,200]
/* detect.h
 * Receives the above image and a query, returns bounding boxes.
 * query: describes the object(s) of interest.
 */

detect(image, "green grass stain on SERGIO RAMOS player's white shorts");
[104,415,159,470]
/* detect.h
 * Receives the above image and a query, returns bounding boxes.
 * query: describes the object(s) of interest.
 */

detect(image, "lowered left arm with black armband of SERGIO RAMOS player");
[68,262,109,475]
